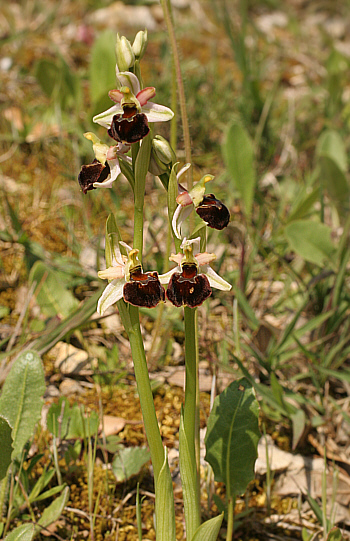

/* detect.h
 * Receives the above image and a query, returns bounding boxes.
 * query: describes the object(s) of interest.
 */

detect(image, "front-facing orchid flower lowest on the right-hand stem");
[159,237,232,308]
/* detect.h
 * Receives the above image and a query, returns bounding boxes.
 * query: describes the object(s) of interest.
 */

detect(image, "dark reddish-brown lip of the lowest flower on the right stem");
[166,264,211,308]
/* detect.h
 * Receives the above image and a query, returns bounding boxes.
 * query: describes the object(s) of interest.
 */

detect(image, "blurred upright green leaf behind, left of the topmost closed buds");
[90,30,117,103]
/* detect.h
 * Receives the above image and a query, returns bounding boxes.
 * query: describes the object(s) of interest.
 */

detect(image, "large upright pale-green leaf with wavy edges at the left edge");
[0,351,45,458]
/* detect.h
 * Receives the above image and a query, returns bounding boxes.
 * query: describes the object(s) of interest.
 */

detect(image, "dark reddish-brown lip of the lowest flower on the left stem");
[123,267,165,308]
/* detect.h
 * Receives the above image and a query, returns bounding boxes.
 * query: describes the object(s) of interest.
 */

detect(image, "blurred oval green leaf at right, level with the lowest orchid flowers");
[284,220,335,266]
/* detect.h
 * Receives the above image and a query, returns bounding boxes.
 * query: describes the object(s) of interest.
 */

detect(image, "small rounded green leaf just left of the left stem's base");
[112,447,150,483]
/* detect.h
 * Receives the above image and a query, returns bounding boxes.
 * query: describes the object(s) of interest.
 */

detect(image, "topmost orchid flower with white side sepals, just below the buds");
[93,71,174,144]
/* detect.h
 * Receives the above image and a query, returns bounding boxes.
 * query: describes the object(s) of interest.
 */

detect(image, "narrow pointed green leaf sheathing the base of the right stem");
[179,411,200,539]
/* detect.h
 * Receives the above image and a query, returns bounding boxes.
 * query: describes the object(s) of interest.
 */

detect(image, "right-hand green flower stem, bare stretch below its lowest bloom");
[180,306,201,528]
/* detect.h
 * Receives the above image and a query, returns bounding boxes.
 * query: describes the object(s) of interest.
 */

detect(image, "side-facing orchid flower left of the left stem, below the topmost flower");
[78,132,130,194]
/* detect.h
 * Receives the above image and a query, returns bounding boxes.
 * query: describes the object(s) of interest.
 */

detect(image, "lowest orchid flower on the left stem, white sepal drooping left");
[97,241,165,315]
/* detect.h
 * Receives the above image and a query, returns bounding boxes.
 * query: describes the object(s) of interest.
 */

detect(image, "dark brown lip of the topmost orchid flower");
[108,112,149,144]
